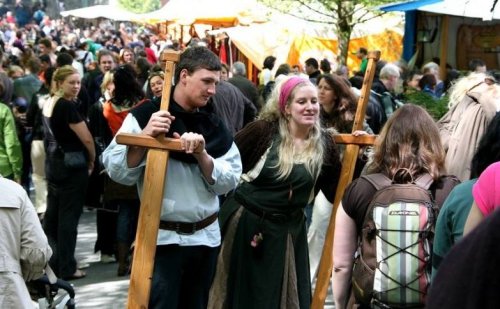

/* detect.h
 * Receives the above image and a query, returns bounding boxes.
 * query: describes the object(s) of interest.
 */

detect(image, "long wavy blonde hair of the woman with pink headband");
[259,77,325,179]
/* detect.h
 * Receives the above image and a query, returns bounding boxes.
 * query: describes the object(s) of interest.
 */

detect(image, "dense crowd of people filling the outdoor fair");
[0,3,500,308]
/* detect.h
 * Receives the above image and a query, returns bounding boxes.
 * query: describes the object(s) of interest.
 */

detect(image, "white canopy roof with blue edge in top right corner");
[418,0,500,20]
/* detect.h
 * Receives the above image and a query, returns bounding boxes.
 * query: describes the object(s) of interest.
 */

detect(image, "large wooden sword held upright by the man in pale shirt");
[116,51,182,309]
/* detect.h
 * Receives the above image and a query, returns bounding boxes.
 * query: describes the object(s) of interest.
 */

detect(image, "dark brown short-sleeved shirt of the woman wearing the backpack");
[342,176,460,235]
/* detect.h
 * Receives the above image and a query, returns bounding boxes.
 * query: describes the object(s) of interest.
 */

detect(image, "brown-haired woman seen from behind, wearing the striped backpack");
[333,104,458,309]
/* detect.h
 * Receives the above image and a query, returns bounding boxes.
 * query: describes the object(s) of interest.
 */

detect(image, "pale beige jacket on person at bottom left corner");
[0,177,52,308]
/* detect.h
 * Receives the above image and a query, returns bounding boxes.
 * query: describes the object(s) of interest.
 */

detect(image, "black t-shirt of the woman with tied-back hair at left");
[50,98,84,151]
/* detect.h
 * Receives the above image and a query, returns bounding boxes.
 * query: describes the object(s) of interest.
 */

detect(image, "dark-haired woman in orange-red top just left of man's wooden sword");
[89,64,144,276]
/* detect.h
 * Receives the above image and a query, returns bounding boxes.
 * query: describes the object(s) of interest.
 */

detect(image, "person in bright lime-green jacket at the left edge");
[0,82,23,183]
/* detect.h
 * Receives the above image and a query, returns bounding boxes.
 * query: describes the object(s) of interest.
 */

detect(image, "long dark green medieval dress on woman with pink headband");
[209,138,314,309]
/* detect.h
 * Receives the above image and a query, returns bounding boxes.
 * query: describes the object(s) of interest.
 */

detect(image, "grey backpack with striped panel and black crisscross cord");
[353,174,438,308]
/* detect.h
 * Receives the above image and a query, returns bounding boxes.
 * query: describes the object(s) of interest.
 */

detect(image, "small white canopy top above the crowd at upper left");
[61,5,137,21]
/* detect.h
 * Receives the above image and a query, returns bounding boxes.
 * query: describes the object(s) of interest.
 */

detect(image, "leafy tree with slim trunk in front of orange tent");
[259,0,393,64]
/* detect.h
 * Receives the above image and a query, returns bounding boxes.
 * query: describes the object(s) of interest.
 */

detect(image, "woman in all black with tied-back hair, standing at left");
[43,65,95,279]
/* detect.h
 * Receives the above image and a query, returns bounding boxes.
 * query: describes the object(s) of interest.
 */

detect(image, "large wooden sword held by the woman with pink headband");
[311,51,380,309]
